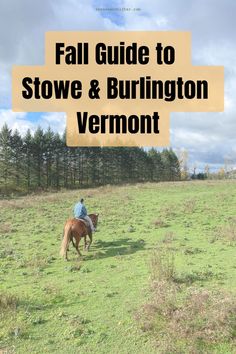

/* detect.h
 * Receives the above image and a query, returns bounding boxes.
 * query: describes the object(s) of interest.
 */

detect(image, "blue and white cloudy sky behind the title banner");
[0,0,236,170]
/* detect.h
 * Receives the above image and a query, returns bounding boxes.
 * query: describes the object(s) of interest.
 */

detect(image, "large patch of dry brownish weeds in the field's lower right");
[135,251,236,353]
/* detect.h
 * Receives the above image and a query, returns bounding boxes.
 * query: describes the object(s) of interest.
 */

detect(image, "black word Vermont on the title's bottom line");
[77,112,159,134]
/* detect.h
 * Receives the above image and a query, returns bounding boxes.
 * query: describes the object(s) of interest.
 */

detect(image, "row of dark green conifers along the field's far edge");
[0,124,180,194]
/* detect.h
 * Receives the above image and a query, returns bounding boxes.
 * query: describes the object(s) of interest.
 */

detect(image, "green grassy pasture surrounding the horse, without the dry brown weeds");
[0,181,236,354]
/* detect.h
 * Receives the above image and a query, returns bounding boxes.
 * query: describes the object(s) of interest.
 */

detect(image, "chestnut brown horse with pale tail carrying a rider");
[60,214,98,260]
